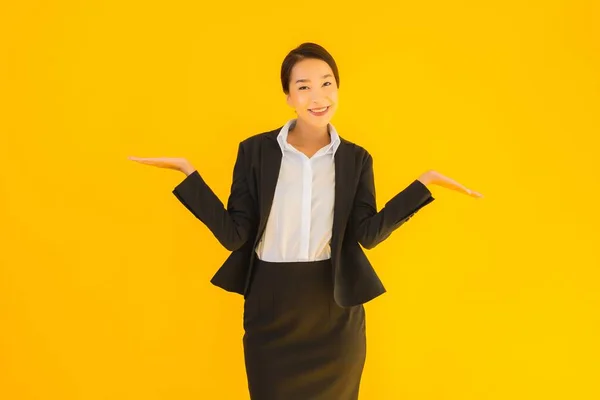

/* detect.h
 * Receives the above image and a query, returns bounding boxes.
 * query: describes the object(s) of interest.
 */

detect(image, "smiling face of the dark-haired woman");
[287,58,338,127]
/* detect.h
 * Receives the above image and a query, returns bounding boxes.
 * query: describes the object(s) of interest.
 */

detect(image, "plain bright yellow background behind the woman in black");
[0,0,600,400]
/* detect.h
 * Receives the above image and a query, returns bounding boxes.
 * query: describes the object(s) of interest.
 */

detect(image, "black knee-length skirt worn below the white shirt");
[243,259,366,400]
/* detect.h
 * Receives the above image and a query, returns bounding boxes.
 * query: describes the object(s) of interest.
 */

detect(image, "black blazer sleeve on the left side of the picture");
[173,143,256,251]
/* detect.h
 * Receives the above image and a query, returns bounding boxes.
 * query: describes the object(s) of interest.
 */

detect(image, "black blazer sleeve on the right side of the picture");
[350,153,435,249]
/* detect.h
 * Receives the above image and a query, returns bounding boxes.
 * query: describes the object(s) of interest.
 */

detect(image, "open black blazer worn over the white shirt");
[173,127,434,307]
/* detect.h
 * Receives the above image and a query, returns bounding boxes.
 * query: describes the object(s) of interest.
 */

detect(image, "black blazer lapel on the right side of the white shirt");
[331,138,356,254]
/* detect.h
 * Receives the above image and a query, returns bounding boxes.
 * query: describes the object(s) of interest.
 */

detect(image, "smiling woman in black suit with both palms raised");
[130,43,482,400]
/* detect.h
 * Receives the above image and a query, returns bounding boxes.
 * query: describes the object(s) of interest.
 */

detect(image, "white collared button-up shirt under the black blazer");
[256,119,340,262]
